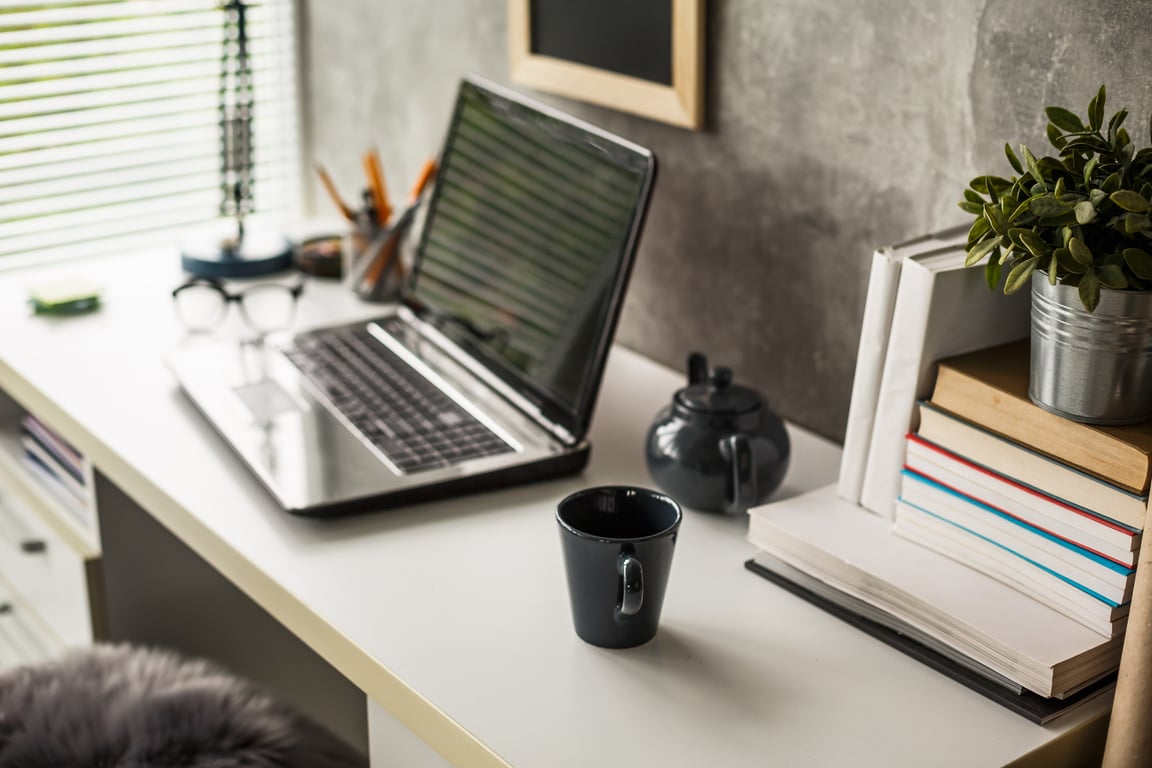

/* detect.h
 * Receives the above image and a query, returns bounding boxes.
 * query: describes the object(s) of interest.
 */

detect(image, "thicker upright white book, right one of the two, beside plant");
[859,238,1031,519]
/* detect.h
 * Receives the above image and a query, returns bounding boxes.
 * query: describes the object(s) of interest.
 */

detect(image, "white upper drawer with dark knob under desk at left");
[0,488,93,646]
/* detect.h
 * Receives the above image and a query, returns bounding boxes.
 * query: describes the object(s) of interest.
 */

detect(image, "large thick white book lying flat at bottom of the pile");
[748,484,1122,697]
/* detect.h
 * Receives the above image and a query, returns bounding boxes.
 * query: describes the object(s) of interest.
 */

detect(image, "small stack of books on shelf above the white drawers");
[20,413,96,530]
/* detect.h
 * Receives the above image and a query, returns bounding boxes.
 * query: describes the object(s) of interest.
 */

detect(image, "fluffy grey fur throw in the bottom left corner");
[0,645,367,768]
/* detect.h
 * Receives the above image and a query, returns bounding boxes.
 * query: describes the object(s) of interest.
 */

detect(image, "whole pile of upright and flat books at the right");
[745,229,1128,723]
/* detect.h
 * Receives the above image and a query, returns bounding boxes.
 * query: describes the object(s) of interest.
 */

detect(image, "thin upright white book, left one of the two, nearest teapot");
[836,225,968,503]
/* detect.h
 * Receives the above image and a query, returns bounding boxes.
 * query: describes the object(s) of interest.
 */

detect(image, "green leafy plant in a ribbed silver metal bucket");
[960,85,1152,424]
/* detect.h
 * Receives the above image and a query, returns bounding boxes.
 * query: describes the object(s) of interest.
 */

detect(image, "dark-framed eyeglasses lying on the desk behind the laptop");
[172,277,304,334]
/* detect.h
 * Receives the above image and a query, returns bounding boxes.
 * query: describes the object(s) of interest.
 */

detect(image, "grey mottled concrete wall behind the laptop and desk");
[301,0,1152,440]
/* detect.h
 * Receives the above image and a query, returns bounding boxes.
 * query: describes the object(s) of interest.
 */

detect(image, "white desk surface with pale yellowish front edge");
[0,253,1106,768]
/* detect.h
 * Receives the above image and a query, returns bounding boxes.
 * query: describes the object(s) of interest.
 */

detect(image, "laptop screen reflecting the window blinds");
[407,79,655,436]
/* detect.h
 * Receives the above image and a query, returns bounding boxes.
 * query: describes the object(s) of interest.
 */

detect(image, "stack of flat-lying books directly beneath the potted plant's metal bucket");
[895,341,1152,638]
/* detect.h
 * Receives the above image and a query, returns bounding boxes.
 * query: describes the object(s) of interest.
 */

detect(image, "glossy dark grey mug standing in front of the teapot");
[556,486,683,648]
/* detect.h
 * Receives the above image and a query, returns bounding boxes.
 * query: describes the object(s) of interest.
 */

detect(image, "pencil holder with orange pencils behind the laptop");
[343,205,417,303]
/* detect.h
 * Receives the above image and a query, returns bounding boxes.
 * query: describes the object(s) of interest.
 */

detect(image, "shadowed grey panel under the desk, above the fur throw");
[97,476,370,765]
